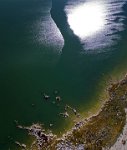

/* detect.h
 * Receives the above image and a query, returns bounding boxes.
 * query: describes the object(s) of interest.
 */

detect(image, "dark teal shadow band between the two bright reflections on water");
[50,0,82,55]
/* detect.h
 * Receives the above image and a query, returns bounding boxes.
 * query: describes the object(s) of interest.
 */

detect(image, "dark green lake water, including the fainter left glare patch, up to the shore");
[0,0,127,150]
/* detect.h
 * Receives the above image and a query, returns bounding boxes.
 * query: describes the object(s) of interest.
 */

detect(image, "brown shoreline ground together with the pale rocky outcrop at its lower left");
[16,75,127,150]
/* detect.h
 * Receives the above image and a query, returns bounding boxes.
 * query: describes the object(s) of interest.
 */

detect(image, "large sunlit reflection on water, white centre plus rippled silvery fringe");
[65,0,126,53]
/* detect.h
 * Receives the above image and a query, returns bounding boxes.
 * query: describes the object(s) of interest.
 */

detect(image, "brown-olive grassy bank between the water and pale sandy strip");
[53,76,127,150]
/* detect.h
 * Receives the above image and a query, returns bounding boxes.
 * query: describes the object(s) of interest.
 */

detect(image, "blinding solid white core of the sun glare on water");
[67,2,106,38]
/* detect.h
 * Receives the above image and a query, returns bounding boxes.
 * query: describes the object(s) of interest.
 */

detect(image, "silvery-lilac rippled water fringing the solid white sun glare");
[65,0,127,53]
